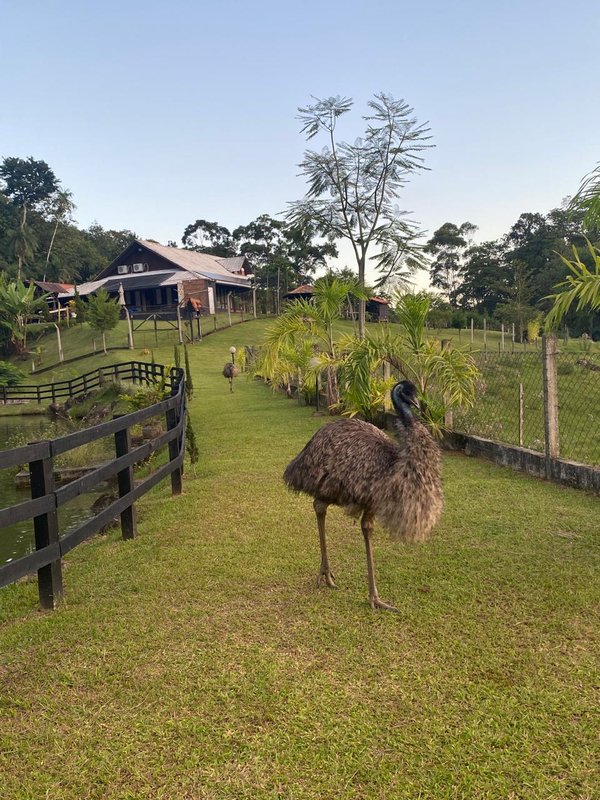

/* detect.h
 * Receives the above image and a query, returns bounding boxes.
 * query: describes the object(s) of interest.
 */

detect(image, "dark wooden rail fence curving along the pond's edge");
[0,361,185,608]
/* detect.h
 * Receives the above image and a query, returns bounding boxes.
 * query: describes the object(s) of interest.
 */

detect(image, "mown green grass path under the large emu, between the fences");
[0,323,600,800]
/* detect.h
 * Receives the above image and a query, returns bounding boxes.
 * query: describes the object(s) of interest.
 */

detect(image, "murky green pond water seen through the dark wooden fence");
[0,415,107,564]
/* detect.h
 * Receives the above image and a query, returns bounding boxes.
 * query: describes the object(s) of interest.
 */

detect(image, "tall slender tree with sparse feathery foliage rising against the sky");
[288,93,431,338]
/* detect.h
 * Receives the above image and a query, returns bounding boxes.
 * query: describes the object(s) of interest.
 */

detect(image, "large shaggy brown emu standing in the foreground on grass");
[283,381,443,611]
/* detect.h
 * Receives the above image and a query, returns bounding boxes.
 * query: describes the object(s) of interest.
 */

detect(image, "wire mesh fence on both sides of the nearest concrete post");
[454,351,600,466]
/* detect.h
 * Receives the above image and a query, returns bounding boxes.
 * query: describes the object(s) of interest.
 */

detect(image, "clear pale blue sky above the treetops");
[0,0,600,286]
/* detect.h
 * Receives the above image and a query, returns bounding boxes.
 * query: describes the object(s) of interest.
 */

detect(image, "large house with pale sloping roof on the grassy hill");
[71,239,253,316]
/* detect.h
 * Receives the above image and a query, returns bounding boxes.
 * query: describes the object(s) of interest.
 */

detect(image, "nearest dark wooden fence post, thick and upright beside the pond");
[29,442,63,609]
